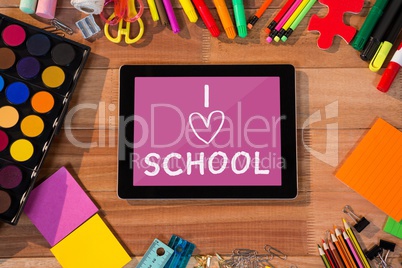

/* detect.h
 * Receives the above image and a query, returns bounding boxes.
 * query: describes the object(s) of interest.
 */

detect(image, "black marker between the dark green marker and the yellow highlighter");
[360,0,402,61]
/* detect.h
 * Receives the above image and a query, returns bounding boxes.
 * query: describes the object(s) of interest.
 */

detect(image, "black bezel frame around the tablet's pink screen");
[117,64,298,199]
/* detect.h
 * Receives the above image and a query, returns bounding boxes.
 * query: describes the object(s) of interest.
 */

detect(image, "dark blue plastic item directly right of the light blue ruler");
[164,235,195,268]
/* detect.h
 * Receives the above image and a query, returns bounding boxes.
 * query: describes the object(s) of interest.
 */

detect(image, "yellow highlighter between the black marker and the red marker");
[369,9,402,72]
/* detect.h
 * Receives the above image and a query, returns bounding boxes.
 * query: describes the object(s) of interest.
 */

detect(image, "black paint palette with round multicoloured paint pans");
[0,14,90,224]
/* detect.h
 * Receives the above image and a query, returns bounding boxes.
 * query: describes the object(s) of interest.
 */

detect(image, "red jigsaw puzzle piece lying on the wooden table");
[308,0,364,49]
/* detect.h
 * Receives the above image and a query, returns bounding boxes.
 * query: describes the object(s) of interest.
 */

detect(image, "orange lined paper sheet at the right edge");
[335,118,402,222]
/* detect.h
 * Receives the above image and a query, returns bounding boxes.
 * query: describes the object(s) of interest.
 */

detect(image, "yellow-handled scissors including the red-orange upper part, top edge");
[104,0,144,44]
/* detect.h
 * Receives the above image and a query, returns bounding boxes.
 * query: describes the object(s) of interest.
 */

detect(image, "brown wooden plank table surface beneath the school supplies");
[0,0,402,268]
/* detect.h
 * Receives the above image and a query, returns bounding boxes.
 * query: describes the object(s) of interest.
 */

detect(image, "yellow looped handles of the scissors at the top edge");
[104,0,144,44]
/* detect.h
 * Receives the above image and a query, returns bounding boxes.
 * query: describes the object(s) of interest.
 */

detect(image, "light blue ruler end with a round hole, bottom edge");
[136,238,174,268]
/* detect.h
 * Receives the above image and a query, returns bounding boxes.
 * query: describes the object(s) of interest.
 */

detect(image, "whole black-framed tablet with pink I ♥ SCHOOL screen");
[118,65,297,199]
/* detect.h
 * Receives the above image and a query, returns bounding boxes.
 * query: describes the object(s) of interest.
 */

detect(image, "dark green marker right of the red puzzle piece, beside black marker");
[352,0,388,51]
